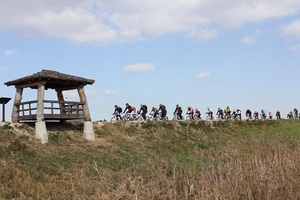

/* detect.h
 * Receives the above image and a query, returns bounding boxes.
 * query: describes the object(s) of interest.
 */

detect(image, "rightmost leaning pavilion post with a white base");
[77,86,95,140]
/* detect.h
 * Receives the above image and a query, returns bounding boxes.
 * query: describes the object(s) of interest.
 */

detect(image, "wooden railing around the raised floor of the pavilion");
[17,100,84,120]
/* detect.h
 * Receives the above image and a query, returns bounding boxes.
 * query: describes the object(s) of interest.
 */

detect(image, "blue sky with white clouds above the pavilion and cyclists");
[0,0,300,121]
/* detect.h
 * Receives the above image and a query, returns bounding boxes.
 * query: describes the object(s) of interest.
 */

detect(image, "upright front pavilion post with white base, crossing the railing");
[35,82,48,144]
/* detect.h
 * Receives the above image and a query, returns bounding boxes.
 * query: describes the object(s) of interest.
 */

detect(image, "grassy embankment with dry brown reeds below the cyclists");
[0,120,300,199]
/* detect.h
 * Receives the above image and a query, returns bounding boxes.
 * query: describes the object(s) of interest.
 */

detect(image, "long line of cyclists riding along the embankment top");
[111,103,300,121]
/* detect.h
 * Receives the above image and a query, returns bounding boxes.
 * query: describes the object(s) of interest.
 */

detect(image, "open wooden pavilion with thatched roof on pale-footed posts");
[5,70,95,143]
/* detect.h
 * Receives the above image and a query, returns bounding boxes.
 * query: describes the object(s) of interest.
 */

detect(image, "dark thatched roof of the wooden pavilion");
[4,69,95,89]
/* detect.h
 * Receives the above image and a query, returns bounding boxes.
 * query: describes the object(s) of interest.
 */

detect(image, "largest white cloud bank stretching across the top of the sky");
[0,0,300,44]
